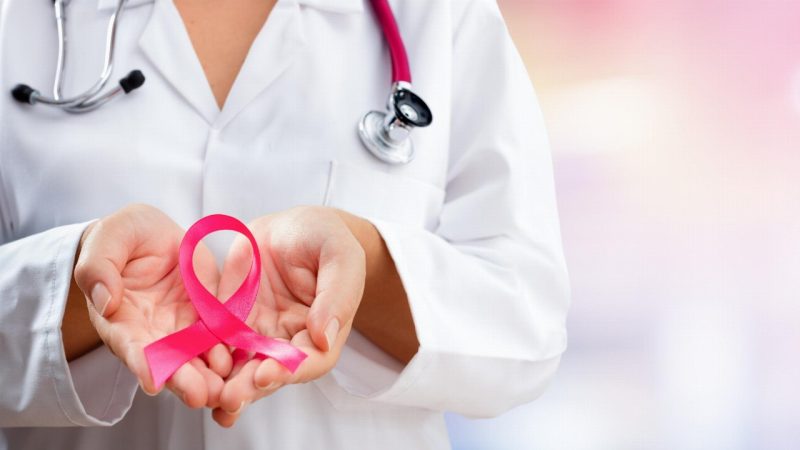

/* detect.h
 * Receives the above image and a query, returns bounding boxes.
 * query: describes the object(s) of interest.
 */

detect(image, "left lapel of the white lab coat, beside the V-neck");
[139,0,219,124]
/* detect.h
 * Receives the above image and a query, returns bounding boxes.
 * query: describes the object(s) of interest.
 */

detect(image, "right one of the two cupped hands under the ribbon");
[213,207,366,427]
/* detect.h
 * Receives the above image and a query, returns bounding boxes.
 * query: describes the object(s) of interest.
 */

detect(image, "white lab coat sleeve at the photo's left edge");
[0,223,137,427]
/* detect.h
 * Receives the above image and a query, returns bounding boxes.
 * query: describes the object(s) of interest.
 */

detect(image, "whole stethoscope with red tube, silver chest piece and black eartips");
[11,0,433,164]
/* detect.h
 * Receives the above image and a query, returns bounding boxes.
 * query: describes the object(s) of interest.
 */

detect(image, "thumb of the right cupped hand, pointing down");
[306,241,366,351]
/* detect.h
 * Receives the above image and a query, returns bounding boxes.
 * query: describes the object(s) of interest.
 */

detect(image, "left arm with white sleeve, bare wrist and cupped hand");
[0,205,230,427]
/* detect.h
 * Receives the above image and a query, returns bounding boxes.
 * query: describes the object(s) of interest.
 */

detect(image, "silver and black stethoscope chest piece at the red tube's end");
[358,82,433,164]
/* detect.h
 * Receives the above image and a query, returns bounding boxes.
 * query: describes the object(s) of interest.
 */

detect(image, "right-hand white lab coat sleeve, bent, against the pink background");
[324,0,569,417]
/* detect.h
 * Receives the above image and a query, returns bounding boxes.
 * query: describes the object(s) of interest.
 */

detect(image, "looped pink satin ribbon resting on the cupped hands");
[144,214,307,388]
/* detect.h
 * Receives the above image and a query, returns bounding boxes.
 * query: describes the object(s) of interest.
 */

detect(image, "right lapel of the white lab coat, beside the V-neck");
[214,0,306,129]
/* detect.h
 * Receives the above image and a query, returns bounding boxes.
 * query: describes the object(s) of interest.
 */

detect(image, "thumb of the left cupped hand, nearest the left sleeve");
[74,219,130,317]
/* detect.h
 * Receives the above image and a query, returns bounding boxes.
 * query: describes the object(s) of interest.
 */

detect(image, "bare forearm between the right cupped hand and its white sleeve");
[339,211,419,363]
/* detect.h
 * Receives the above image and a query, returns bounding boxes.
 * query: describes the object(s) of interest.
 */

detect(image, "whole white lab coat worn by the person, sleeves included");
[0,0,568,450]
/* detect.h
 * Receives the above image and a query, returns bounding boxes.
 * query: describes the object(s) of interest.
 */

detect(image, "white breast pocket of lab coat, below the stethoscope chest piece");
[325,161,444,230]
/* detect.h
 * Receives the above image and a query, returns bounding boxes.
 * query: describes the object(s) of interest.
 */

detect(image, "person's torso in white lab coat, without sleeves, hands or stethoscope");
[0,0,453,450]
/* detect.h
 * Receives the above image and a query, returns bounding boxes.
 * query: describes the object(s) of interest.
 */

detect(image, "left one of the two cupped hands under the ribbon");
[74,205,232,408]
